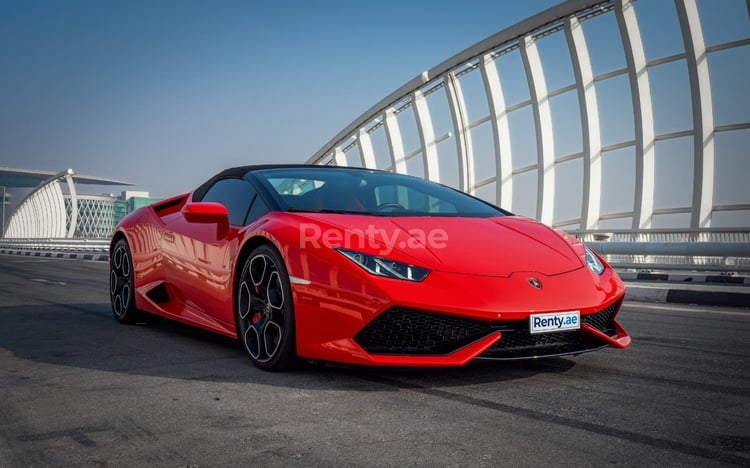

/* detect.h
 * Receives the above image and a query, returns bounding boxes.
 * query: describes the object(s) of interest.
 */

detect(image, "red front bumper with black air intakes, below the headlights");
[293,268,630,366]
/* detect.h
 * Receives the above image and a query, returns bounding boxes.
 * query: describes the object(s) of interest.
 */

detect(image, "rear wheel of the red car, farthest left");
[109,239,142,323]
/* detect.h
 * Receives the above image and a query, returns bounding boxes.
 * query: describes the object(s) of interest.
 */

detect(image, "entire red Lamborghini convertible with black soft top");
[110,165,630,370]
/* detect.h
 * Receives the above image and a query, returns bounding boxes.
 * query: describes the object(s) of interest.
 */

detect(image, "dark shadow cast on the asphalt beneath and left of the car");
[0,304,576,391]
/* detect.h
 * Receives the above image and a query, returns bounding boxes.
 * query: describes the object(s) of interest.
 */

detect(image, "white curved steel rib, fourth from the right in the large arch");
[519,35,555,224]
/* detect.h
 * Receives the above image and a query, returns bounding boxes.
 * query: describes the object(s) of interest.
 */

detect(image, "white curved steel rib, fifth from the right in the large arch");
[479,54,513,211]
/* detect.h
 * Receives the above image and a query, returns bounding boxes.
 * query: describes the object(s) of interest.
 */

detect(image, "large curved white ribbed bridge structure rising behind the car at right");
[308,0,750,230]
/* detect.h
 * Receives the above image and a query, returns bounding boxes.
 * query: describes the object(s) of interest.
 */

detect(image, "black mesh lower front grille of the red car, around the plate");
[354,301,621,359]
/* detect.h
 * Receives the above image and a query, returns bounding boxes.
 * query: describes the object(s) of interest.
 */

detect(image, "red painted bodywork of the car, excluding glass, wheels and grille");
[113,166,630,366]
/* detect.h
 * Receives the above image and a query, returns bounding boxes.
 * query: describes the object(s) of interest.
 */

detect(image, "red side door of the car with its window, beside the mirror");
[164,178,257,329]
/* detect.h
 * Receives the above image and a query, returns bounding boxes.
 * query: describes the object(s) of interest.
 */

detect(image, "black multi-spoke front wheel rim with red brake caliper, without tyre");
[237,253,286,363]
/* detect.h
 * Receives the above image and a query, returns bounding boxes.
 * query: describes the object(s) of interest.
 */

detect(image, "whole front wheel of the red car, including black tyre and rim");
[241,245,297,371]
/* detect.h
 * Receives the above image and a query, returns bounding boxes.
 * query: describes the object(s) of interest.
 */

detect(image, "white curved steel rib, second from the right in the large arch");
[615,0,655,229]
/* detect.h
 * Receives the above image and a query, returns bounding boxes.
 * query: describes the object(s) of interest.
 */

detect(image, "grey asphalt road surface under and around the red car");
[0,255,750,467]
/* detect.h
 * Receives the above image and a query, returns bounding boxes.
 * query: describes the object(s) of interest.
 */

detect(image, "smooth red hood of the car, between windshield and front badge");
[294,214,583,277]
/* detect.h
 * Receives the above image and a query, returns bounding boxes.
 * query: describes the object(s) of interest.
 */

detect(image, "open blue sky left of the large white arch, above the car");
[0,0,558,196]
